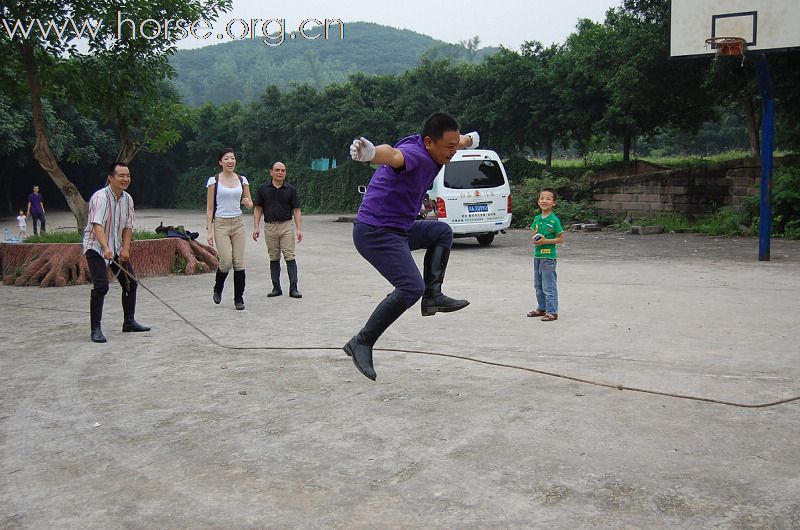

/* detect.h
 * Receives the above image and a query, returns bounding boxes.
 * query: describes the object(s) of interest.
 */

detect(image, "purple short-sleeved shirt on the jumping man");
[356,134,442,230]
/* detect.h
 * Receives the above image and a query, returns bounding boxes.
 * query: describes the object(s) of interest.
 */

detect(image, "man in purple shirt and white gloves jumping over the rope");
[343,113,480,381]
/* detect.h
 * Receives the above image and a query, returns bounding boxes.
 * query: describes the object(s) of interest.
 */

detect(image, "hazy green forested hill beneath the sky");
[170,22,497,106]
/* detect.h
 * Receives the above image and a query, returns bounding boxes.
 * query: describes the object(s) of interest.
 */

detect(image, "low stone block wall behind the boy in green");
[592,159,764,218]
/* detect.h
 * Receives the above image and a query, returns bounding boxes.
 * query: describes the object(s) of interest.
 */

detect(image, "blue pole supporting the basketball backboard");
[752,53,775,261]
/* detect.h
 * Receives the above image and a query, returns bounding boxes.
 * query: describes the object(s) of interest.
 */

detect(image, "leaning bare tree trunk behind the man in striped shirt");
[19,41,89,232]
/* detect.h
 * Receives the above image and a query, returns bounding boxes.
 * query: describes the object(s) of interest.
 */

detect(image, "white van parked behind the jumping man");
[428,149,511,245]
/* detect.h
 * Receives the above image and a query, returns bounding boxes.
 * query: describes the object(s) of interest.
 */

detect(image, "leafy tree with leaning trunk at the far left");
[0,0,231,230]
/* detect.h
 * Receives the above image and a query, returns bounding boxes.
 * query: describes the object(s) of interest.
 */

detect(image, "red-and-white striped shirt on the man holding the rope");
[83,186,133,256]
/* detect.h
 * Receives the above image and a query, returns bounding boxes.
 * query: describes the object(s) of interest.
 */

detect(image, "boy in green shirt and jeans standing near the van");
[528,188,564,322]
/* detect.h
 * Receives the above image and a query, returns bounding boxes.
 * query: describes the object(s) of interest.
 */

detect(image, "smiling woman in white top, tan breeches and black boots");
[206,148,253,310]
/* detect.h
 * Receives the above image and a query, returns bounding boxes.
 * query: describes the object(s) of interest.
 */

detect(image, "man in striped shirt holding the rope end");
[83,162,150,342]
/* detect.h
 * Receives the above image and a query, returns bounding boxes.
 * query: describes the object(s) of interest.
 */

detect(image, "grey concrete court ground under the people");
[0,210,800,529]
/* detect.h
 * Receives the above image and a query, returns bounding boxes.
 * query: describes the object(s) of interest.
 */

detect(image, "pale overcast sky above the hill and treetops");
[180,0,621,50]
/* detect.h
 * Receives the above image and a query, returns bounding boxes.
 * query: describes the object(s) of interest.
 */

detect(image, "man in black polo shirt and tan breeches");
[253,162,303,298]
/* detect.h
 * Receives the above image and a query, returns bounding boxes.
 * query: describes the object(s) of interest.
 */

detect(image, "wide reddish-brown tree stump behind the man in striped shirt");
[0,237,218,287]
